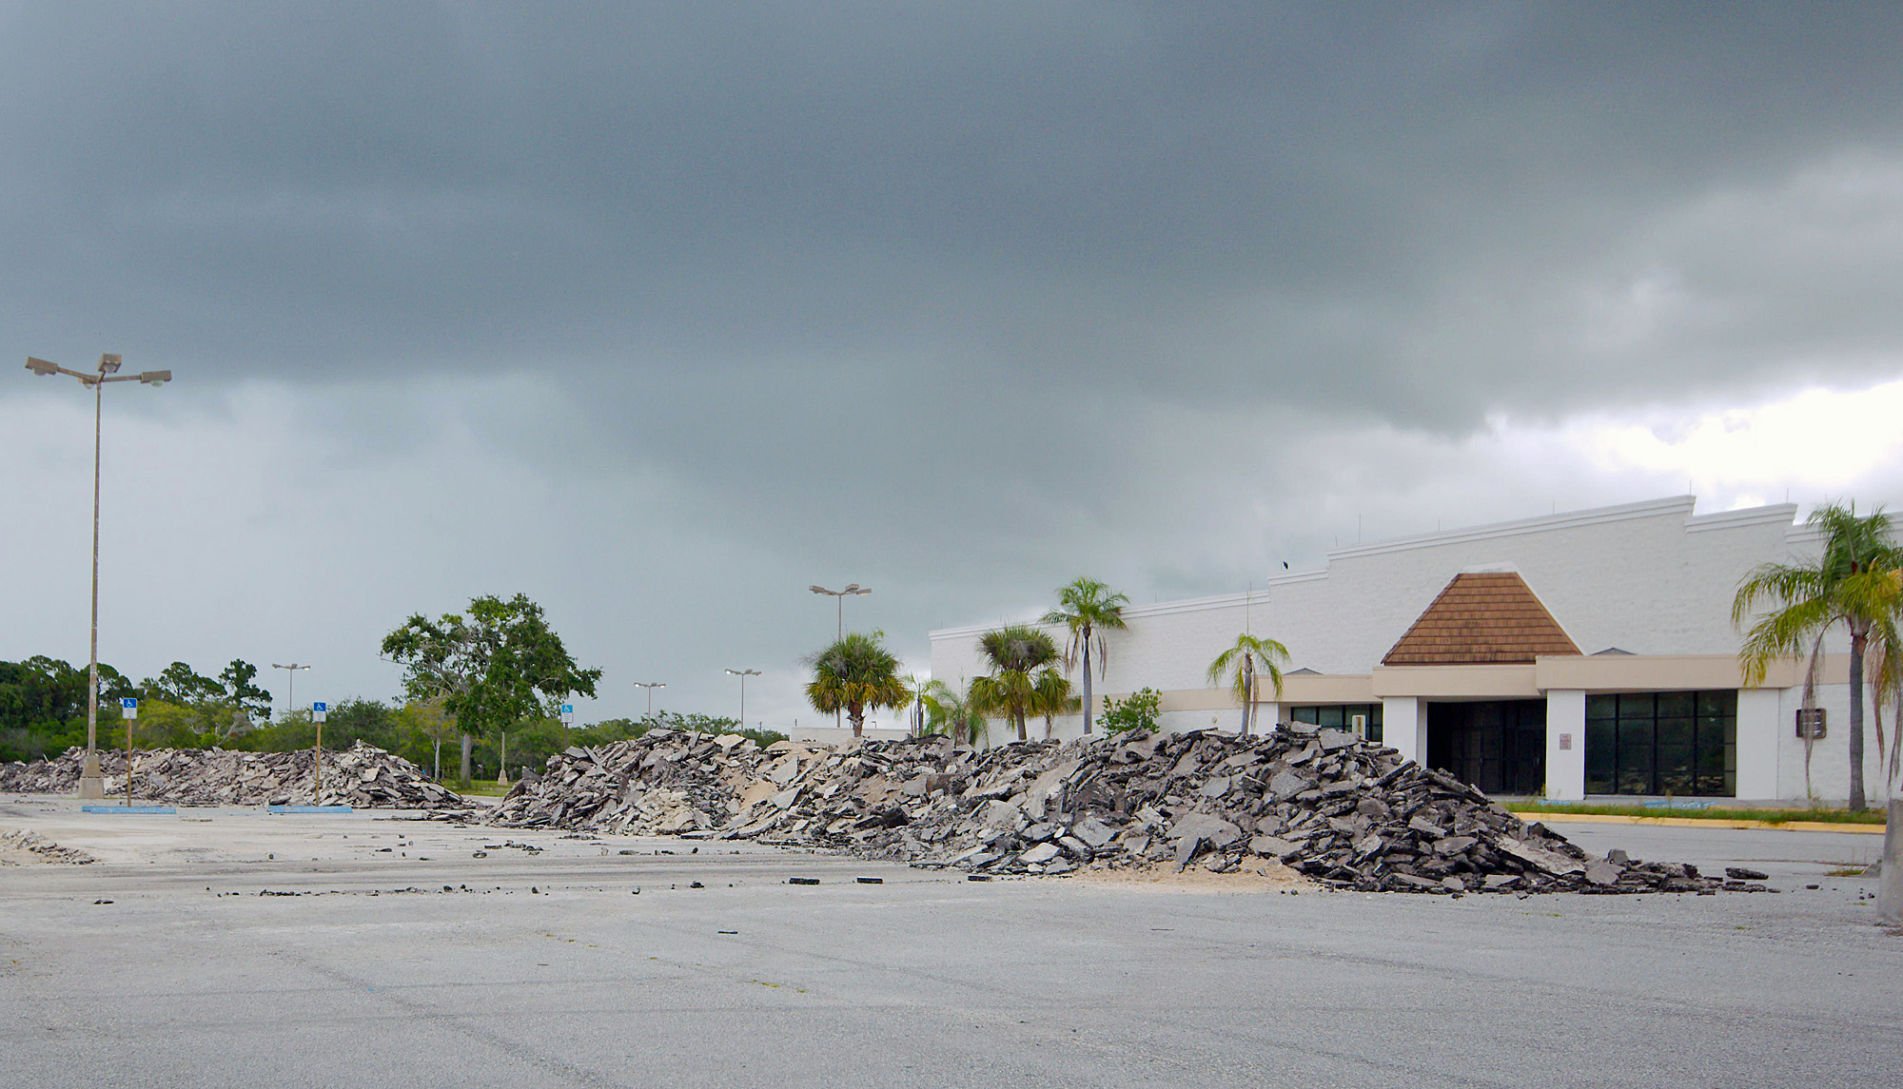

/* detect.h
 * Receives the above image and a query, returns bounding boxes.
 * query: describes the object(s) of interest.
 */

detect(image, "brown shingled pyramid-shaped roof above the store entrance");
[1382,571,1579,666]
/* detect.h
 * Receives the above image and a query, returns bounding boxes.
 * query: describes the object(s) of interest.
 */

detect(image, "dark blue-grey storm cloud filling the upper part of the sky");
[0,4,1903,423]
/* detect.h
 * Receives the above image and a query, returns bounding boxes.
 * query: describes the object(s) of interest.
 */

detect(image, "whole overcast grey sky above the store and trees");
[0,0,1903,725]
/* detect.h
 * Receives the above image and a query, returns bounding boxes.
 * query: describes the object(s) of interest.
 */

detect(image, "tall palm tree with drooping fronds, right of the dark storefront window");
[1732,503,1903,809]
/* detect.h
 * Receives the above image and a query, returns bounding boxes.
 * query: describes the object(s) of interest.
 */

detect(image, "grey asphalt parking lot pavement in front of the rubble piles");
[0,796,1903,1087]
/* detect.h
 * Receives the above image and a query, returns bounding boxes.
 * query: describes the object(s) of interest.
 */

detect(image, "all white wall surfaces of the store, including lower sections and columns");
[931,497,1884,802]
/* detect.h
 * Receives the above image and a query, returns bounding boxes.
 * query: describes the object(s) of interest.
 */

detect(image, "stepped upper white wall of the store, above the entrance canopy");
[931,497,1815,693]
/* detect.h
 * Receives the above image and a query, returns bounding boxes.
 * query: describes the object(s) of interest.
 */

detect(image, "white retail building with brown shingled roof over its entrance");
[931,497,1884,802]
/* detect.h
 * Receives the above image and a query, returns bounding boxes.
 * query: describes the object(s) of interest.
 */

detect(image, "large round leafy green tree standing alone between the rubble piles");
[383,594,601,782]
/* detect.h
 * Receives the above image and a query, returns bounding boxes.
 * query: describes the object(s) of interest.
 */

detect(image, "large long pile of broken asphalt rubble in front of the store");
[489,725,1760,893]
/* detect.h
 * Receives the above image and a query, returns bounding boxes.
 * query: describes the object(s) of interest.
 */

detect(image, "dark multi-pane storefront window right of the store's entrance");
[1585,691,1737,798]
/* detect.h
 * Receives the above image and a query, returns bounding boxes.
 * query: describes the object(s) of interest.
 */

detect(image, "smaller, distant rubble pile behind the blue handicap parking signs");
[0,741,464,809]
